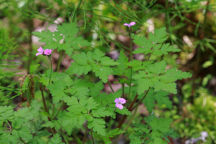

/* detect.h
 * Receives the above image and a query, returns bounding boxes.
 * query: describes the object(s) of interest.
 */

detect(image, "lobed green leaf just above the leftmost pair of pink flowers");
[33,23,90,56]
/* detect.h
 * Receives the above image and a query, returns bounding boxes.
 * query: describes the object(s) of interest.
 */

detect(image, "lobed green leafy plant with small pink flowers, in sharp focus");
[0,22,191,144]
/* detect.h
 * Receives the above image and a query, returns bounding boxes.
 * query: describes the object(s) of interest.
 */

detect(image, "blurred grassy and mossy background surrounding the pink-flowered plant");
[0,0,216,143]
